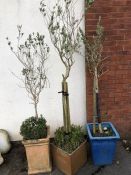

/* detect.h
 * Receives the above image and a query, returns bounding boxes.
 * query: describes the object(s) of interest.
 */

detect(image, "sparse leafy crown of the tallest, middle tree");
[40,0,84,80]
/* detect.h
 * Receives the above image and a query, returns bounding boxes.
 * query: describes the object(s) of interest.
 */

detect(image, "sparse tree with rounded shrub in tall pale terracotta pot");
[7,26,51,174]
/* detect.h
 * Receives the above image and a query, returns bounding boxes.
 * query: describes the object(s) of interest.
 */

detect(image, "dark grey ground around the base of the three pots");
[0,142,131,175]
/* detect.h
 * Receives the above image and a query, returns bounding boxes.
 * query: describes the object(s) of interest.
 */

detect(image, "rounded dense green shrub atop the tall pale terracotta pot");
[20,115,47,140]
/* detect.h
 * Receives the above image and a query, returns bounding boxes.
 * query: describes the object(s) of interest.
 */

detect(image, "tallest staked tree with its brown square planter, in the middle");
[40,0,87,175]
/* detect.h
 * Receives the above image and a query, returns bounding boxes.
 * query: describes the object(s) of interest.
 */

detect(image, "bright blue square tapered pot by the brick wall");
[87,122,120,166]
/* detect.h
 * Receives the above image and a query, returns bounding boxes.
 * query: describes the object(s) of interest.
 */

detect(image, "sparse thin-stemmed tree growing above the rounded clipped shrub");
[6,25,50,117]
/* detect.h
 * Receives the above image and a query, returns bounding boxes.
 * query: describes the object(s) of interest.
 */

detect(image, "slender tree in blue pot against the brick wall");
[82,18,120,165]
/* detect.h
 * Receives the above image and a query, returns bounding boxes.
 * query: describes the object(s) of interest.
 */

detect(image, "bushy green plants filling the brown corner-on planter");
[54,125,85,153]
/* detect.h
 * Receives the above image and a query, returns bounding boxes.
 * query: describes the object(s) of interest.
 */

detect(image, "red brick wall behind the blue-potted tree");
[85,0,131,137]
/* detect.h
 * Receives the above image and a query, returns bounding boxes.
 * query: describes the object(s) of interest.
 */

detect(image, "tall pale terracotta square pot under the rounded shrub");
[22,128,52,174]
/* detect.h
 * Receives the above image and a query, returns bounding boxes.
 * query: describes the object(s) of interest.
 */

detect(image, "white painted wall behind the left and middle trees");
[0,0,86,140]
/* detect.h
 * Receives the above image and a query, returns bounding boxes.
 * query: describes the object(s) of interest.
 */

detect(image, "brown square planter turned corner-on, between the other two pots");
[51,141,87,175]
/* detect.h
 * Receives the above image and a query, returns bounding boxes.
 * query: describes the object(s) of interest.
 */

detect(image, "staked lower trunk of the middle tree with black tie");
[62,80,71,133]
